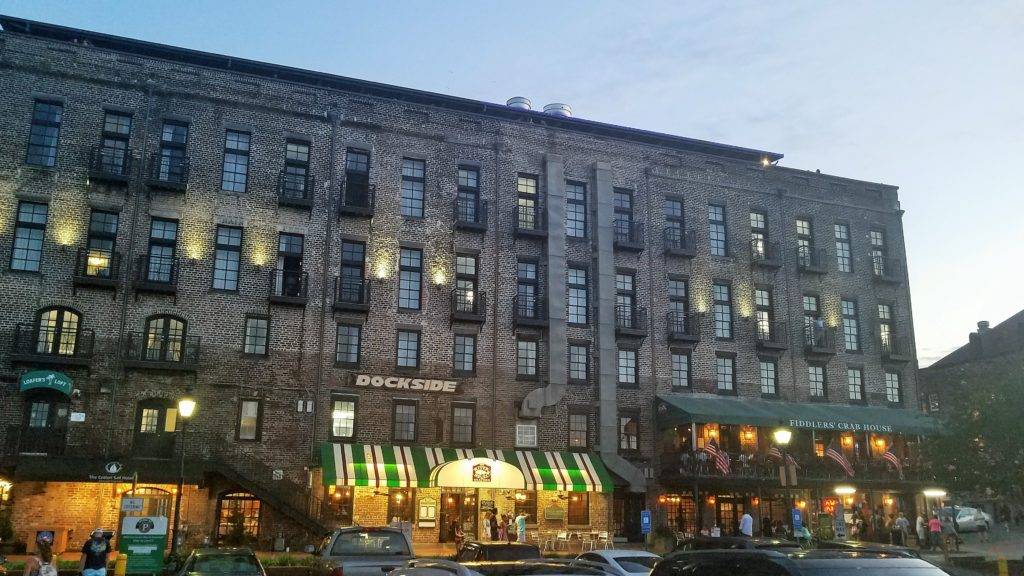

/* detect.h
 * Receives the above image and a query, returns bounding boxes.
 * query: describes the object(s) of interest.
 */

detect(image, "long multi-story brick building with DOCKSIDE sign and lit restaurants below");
[0,17,929,545]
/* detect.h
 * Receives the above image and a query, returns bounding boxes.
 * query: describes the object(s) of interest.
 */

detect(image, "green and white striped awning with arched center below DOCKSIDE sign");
[321,444,614,492]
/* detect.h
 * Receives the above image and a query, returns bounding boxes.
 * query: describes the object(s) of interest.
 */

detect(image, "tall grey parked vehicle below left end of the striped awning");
[315,526,414,576]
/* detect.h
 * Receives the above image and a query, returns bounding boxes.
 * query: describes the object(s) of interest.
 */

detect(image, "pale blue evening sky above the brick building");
[0,0,1024,366]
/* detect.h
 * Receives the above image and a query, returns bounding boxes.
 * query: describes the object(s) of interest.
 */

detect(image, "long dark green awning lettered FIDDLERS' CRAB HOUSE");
[657,394,939,435]
